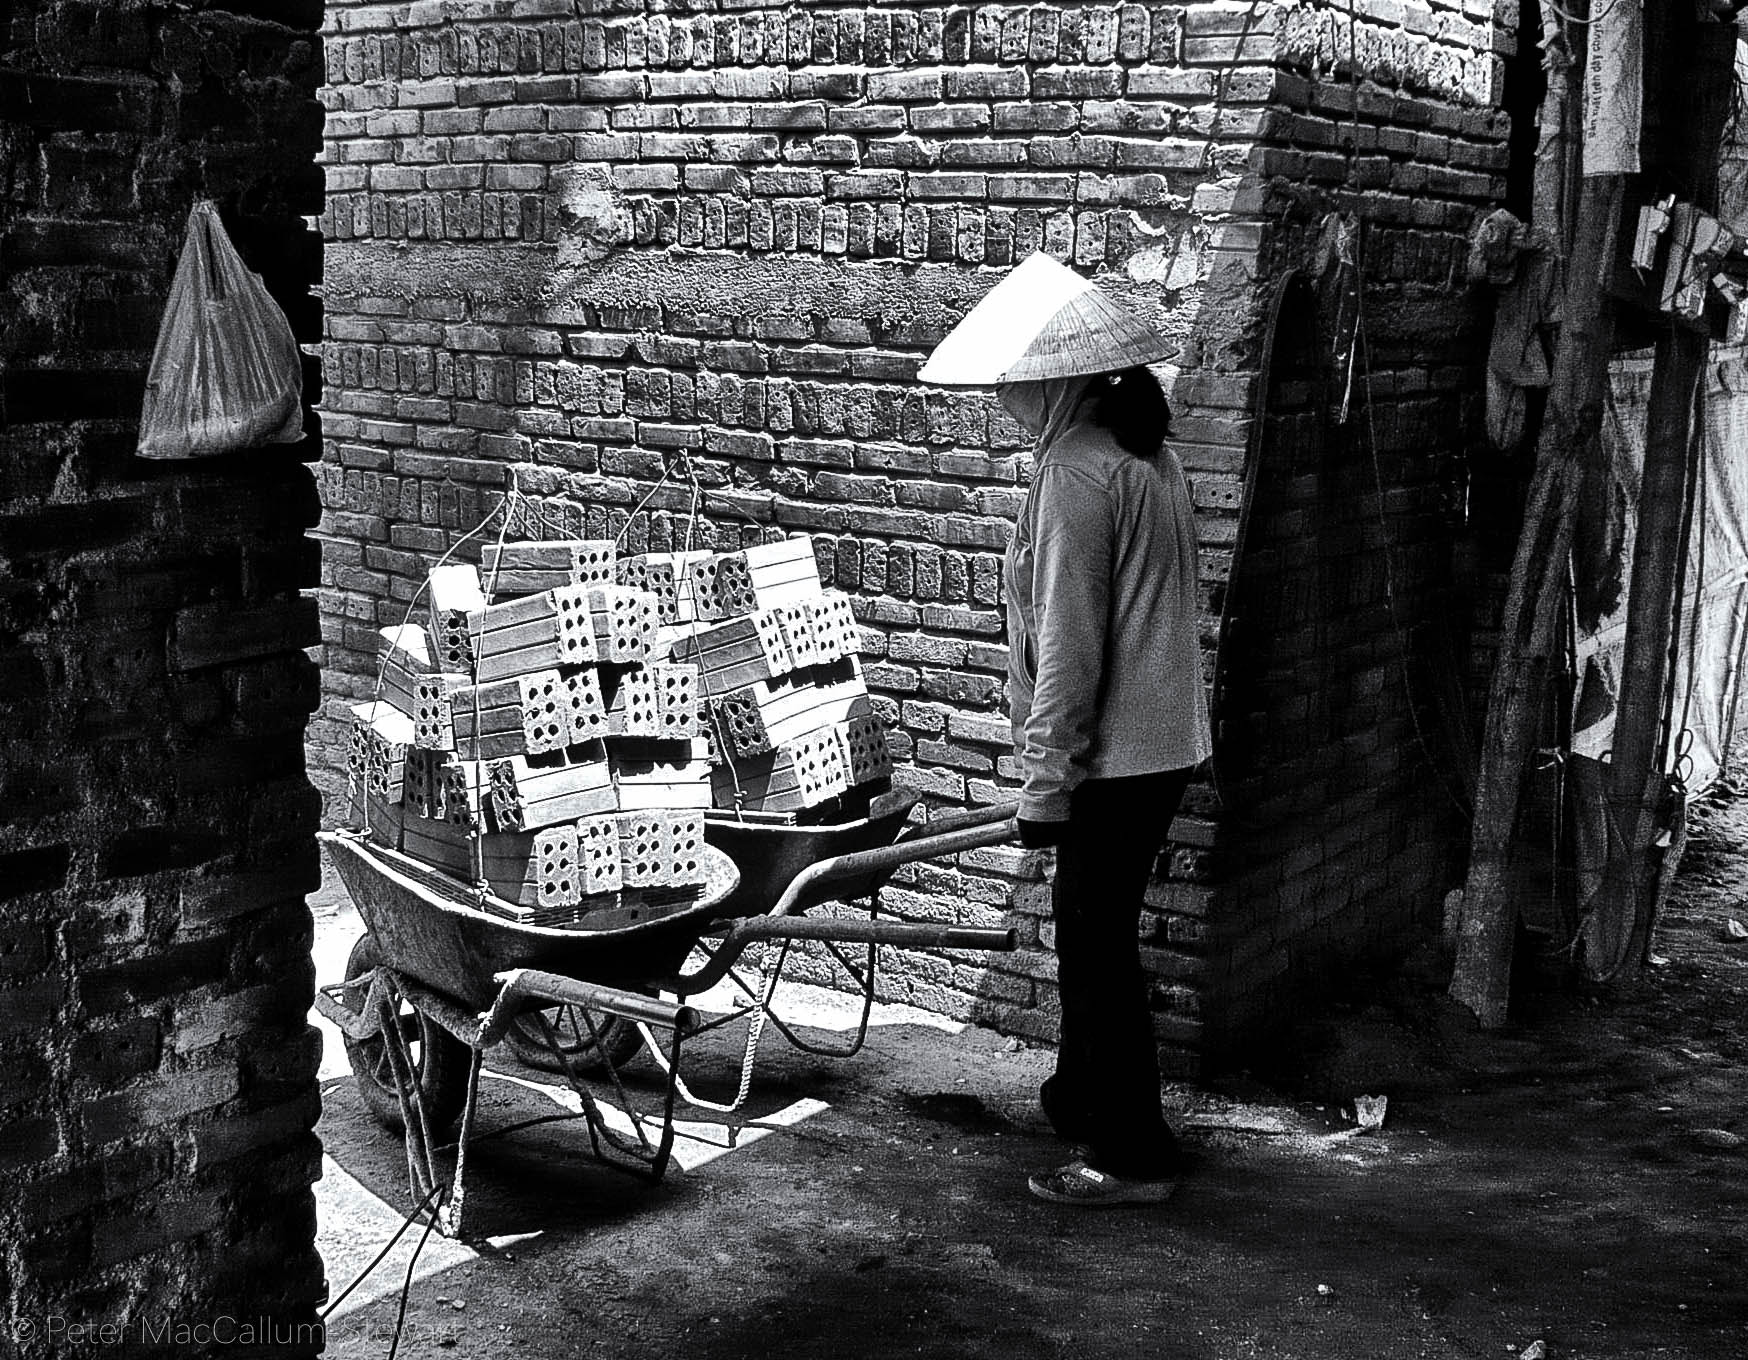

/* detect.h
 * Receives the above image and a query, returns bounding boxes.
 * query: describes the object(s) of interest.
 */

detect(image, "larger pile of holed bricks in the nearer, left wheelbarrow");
[348,540,710,925]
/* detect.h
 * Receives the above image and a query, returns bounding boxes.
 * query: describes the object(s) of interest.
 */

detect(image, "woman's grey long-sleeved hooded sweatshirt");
[1003,379,1213,822]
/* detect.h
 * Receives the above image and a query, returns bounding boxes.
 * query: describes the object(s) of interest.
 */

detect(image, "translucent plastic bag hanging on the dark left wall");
[136,199,304,458]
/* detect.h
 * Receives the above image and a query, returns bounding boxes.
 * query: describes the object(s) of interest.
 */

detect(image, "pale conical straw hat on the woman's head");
[918,250,1176,386]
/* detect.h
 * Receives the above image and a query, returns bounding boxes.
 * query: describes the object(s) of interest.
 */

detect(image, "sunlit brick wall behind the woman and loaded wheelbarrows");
[313,0,1503,1066]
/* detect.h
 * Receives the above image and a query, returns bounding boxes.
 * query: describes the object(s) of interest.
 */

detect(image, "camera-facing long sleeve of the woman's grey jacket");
[1019,463,1115,822]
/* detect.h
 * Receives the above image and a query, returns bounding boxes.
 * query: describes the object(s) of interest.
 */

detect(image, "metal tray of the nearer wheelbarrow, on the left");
[322,832,739,1010]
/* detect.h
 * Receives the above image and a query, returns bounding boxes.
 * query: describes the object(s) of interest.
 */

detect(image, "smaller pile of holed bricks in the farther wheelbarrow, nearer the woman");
[673,535,891,815]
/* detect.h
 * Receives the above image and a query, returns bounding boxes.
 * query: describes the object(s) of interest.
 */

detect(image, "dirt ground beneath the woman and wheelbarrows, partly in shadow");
[318,787,1748,1360]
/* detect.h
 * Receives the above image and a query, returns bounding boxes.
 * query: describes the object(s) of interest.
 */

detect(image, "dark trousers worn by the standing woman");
[1038,769,1190,1178]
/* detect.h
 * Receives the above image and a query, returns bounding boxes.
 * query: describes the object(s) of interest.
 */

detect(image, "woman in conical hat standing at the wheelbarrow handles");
[921,255,1211,1206]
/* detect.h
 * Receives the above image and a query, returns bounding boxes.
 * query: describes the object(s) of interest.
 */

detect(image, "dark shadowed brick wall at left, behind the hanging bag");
[0,0,322,1357]
